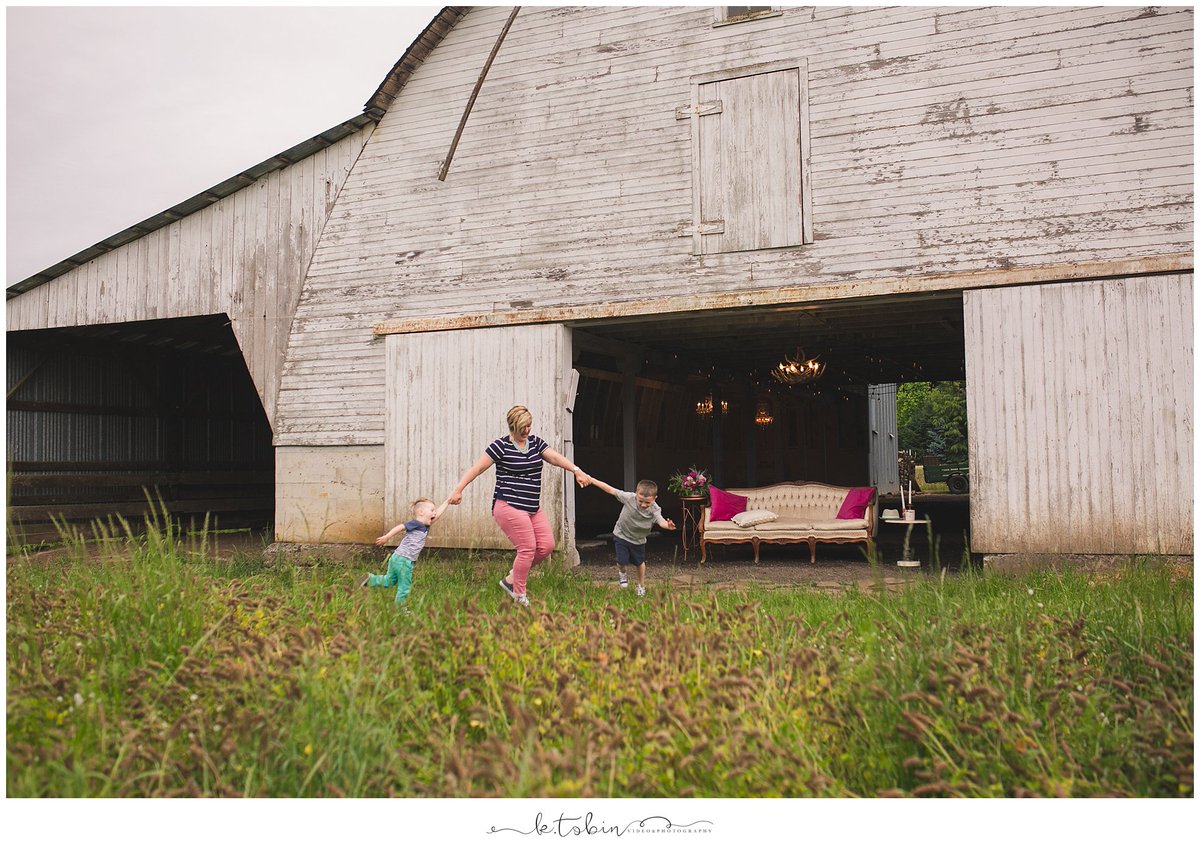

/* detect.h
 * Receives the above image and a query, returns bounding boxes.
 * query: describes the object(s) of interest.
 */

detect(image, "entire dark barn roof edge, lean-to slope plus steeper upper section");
[5,6,469,300]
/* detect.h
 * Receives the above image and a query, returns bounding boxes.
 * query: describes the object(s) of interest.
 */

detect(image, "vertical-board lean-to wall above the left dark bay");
[6,127,371,425]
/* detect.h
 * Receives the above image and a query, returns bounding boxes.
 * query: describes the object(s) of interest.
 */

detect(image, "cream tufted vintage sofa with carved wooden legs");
[698,482,878,563]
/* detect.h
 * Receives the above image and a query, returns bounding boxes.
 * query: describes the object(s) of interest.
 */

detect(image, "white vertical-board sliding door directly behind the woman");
[384,325,575,559]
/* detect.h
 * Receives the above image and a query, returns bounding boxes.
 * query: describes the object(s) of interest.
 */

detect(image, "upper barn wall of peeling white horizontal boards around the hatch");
[277,7,1193,445]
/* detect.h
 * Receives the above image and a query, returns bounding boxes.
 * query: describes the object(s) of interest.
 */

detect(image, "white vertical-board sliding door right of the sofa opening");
[964,275,1194,554]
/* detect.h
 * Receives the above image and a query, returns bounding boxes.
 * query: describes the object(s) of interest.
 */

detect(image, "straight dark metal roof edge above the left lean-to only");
[5,113,376,301]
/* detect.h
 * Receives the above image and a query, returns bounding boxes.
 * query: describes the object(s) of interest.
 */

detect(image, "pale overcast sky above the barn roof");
[6,6,440,284]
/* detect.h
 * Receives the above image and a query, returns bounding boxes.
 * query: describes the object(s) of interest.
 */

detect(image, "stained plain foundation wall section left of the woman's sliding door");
[275,446,384,542]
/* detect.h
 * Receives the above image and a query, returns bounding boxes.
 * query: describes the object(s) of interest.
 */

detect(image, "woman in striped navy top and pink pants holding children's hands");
[449,406,592,607]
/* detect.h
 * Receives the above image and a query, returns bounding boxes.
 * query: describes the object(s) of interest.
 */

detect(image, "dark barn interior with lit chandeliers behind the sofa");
[572,290,967,537]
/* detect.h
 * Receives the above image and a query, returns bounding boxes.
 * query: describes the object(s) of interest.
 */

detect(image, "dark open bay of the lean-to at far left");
[7,314,275,542]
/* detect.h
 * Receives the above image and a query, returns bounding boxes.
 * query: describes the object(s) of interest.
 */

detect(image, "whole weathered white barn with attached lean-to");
[7,6,1193,554]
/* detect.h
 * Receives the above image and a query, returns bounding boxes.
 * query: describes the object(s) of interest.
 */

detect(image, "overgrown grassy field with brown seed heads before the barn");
[6,520,1193,797]
